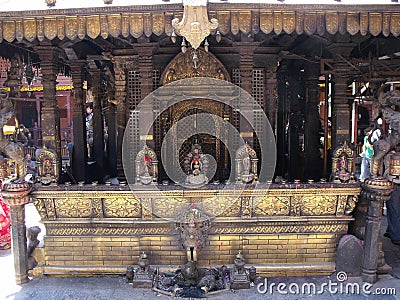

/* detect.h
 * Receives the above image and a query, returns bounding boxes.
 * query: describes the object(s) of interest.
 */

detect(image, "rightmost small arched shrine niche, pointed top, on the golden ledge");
[332,141,354,183]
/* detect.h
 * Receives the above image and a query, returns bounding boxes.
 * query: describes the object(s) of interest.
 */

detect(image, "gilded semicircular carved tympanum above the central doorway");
[161,48,230,85]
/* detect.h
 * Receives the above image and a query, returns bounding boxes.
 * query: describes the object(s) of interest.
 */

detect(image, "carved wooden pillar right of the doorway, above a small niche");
[235,43,258,147]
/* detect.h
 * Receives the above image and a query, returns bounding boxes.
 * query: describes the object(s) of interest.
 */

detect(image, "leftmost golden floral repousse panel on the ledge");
[54,197,92,218]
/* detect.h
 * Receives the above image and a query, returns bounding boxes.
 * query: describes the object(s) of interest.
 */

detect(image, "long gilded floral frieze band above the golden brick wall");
[32,184,360,220]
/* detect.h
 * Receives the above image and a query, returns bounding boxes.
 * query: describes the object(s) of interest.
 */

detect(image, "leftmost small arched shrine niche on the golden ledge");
[36,148,59,185]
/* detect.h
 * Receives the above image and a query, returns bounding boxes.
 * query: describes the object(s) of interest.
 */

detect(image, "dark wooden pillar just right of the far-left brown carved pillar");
[70,60,88,181]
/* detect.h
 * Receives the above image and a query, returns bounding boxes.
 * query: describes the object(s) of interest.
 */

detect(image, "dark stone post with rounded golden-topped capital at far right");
[361,178,392,283]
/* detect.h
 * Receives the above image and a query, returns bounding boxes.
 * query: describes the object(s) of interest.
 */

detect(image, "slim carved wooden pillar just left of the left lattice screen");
[112,56,127,179]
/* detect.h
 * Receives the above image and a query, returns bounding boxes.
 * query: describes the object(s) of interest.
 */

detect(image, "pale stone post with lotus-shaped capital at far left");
[2,183,30,284]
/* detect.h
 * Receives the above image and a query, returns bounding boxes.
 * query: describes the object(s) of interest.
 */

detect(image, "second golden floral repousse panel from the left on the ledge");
[103,197,141,218]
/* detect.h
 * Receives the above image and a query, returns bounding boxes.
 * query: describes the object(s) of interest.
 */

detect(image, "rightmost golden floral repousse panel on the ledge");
[300,194,337,216]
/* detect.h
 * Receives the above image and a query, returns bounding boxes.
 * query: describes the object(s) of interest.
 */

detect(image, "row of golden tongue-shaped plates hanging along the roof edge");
[0,9,400,42]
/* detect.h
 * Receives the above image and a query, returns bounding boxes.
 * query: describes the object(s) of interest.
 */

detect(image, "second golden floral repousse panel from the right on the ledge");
[253,196,290,216]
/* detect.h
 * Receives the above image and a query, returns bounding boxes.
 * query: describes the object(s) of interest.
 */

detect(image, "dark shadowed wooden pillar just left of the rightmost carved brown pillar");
[304,64,322,180]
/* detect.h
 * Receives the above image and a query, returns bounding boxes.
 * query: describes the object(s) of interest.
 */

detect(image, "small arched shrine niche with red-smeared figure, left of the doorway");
[136,145,158,184]
